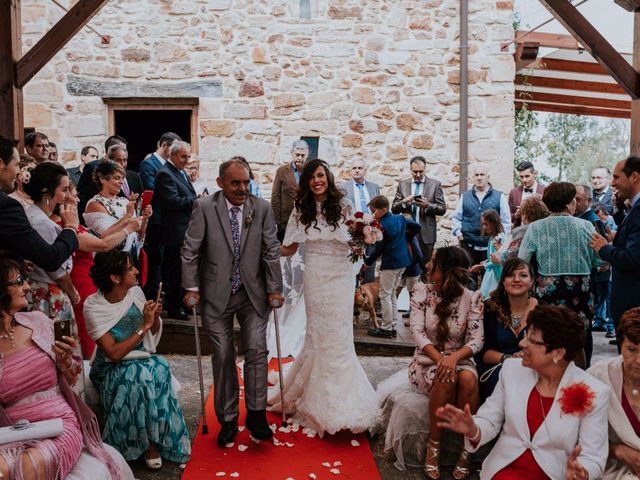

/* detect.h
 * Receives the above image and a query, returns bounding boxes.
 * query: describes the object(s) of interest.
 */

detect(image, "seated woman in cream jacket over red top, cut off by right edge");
[588,308,640,480]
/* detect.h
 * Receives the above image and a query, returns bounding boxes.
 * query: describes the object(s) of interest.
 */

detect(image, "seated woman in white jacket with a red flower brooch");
[437,305,609,480]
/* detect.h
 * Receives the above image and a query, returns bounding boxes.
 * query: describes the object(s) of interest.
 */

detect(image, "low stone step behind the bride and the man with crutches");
[158,316,415,357]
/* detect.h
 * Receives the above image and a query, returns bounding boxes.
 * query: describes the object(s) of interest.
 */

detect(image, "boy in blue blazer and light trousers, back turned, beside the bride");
[364,195,422,338]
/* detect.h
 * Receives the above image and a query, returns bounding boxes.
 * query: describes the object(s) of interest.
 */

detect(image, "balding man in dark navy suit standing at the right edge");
[591,156,640,351]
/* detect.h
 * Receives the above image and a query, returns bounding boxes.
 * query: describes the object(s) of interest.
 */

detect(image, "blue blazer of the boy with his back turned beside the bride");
[365,212,422,270]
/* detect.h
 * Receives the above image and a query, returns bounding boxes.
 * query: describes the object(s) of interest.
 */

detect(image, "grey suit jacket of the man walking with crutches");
[181,191,282,317]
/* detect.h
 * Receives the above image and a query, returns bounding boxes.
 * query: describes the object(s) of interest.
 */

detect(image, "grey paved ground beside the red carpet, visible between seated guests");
[132,333,616,480]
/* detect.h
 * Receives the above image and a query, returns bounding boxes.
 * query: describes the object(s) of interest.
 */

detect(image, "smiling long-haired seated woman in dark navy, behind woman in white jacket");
[476,258,538,404]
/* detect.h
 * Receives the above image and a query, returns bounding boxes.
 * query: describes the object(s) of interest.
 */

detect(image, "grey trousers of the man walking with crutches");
[202,288,269,423]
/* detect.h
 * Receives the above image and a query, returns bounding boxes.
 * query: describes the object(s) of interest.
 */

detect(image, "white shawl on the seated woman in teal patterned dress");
[82,286,162,360]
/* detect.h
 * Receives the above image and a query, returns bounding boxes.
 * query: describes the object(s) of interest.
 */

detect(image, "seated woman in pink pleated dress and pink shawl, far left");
[0,257,133,480]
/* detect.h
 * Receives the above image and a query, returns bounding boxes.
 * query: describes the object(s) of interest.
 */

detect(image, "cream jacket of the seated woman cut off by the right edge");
[588,356,640,480]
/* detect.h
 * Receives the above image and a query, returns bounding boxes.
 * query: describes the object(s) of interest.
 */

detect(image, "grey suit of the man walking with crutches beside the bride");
[181,191,282,422]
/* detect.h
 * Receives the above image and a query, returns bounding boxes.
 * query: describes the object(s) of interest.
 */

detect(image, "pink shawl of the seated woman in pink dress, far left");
[0,312,123,480]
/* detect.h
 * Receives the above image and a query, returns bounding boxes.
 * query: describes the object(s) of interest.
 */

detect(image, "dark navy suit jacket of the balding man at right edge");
[598,202,640,325]
